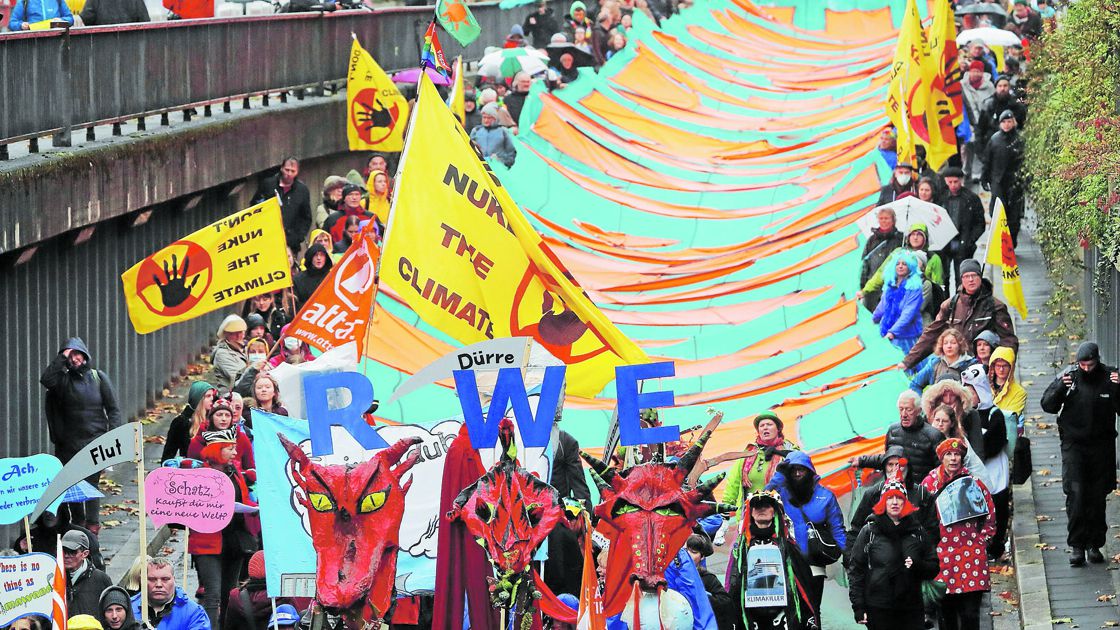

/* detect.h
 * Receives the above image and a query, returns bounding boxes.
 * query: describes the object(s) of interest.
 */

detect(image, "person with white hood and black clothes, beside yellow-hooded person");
[961,363,1011,562]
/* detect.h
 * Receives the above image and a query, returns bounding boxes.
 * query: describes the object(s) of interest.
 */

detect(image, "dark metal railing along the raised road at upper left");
[0,3,532,153]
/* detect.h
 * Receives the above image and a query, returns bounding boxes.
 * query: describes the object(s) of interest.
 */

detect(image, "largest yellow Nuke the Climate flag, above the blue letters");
[372,75,648,398]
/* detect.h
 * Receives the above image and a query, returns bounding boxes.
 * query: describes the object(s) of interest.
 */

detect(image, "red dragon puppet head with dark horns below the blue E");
[580,430,735,615]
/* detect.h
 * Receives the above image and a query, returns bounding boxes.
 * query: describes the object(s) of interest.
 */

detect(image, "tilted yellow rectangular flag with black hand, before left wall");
[121,197,291,334]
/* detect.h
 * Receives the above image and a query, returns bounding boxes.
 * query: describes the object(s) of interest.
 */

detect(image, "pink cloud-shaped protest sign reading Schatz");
[143,467,233,534]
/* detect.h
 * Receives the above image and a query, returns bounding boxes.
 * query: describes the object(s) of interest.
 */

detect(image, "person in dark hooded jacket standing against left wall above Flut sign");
[39,337,122,534]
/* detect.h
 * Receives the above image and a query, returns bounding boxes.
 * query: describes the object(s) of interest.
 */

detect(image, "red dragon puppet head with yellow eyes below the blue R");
[278,434,420,630]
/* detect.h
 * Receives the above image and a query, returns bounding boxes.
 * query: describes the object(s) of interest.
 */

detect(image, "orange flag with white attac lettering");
[284,224,381,353]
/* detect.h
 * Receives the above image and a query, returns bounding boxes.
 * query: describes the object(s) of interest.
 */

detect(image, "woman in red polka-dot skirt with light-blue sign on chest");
[922,437,996,630]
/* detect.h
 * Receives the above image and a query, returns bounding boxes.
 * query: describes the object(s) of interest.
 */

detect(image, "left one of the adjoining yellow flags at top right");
[886,0,930,165]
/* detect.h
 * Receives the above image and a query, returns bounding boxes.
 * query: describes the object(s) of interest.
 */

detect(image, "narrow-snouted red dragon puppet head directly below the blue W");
[448,418,575,630]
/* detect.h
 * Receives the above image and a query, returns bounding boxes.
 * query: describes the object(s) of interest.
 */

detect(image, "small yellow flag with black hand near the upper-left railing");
[346,38,409,151]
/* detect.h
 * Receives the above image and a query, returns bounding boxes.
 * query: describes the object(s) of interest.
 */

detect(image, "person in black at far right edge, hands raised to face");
[1042,341,1120,566]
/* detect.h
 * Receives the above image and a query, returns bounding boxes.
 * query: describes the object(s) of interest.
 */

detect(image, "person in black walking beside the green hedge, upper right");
[980,110,1026,247]
